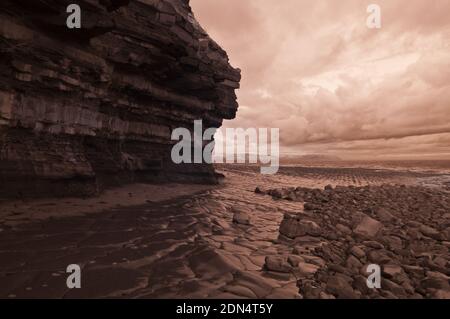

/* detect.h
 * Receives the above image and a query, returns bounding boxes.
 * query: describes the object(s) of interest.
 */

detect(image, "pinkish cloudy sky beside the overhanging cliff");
[190,0,450,159]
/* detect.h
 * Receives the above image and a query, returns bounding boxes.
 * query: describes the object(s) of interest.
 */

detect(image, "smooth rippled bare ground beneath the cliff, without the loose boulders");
[0,166,450,298]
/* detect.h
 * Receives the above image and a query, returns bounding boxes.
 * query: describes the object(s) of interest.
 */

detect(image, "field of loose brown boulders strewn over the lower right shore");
[256,185,450,298]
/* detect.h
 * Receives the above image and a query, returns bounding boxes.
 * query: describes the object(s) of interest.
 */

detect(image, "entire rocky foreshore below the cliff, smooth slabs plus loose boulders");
[0,165,450,299]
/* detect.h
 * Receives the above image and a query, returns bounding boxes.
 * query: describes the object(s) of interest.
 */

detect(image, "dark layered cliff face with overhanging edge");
[0,0,240,197]
